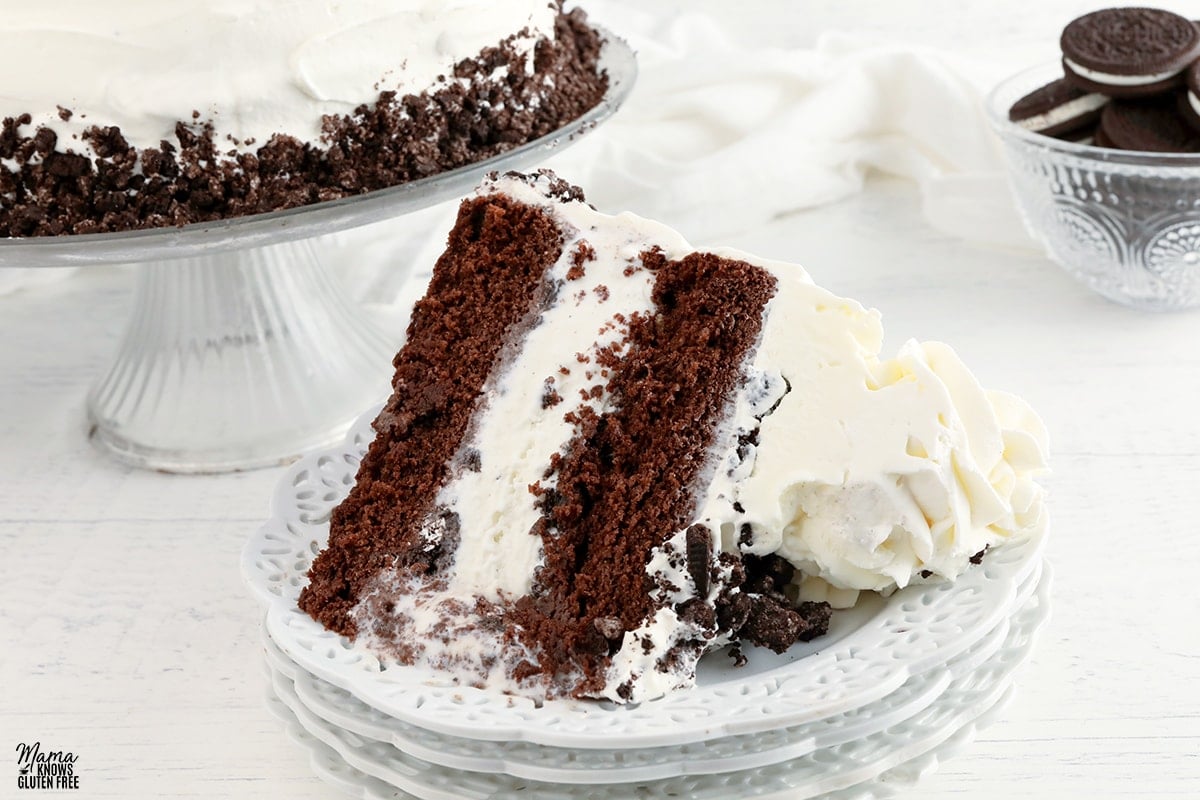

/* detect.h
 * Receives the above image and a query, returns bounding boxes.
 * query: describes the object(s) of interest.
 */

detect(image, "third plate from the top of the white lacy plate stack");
[258,563,1050,800]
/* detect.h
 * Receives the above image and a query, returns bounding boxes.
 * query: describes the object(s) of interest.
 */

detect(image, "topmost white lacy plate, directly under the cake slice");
[242,409,1045,750]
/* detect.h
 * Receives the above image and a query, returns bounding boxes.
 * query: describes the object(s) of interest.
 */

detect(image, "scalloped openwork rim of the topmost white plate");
[241,403,1046,748]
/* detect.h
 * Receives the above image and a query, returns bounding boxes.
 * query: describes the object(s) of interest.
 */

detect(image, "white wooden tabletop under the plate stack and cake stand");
[0,2,1200,800]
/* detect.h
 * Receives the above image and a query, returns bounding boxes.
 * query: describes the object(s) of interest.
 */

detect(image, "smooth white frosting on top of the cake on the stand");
[0,0,556,152]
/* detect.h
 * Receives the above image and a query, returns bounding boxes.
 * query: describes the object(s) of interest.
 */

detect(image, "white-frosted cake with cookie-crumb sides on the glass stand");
[0,0,607,236]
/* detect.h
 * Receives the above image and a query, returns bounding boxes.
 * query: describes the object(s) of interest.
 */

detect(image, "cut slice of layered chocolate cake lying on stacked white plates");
[300,173,1046,703]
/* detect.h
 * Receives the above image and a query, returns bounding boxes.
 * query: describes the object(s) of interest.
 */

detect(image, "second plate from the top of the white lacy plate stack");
[264,567,1049,783]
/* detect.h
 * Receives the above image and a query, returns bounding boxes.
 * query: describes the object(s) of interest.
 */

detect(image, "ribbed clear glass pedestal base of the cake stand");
[88,239,396,473]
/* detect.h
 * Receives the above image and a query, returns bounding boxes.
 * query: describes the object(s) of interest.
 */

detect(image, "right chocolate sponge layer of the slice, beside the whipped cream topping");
[512,252,775,696]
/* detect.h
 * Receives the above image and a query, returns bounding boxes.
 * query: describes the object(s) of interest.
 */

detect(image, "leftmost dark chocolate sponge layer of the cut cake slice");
[300,189,569,636]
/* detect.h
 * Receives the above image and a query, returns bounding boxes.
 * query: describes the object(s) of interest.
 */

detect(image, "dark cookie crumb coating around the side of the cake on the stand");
[0,10,607,236]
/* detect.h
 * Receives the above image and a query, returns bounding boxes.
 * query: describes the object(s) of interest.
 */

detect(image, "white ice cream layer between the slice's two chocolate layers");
[436,179,683,600]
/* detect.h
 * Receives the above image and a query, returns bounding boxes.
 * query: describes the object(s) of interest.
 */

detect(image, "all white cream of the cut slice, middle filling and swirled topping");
[356,178,1046,702]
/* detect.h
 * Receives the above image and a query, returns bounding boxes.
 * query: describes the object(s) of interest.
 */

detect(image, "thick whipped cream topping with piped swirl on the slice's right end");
[698,272,1046,604]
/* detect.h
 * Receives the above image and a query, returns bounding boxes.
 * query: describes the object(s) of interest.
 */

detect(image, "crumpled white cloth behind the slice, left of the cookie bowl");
[542,10,1027,245]
